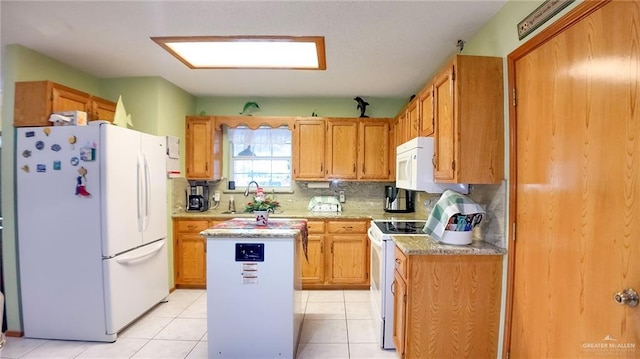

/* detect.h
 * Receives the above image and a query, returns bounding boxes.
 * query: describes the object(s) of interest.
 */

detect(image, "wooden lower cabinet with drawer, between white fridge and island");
[173,218,221,288]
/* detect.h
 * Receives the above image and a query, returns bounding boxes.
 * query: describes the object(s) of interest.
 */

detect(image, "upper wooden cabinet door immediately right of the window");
[293,120,325,179]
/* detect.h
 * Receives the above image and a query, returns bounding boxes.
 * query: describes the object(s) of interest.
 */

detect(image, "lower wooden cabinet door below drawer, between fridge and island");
[174,233,207,285]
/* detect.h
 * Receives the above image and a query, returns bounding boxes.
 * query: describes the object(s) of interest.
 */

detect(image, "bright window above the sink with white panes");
[227,126,292,189]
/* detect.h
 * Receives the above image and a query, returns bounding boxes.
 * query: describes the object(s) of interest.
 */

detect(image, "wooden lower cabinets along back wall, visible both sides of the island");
[173,217,369,289]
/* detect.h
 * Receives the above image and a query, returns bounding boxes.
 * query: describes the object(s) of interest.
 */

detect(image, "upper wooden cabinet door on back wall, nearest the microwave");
[358,120,391,180]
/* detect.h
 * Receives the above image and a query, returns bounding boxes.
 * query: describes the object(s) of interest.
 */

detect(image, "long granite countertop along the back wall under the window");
[172,209,427,221]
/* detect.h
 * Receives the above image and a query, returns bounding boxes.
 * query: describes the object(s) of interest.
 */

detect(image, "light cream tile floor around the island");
[0,289,396,359]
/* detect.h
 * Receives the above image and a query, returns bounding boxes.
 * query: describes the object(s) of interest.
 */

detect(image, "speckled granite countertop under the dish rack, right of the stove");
[392,235,507,256]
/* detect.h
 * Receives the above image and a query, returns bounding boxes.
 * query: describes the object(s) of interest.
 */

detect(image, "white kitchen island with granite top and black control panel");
[200,218,307,358]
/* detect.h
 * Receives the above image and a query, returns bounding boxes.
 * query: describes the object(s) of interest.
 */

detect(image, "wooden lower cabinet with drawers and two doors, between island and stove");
[299,220,369,289]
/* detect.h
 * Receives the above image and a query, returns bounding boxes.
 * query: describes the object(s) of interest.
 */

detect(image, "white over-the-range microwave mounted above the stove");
[396,137,469,194]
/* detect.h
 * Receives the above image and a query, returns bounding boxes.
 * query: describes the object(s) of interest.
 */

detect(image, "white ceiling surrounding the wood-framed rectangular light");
[0,0,506,98]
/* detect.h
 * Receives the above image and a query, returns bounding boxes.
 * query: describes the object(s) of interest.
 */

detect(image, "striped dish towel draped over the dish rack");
[422,189,485,241]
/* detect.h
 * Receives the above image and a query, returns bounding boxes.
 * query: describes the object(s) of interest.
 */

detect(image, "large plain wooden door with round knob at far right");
[505,1,640,359]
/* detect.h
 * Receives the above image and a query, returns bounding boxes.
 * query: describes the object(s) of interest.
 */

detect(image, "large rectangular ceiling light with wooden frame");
[151,36,327,70]
